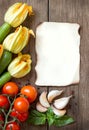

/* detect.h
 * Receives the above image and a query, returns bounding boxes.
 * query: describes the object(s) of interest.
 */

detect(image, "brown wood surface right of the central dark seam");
[49,0,89,130]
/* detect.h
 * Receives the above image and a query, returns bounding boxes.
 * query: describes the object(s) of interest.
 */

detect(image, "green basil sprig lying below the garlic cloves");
[28,108,74,127]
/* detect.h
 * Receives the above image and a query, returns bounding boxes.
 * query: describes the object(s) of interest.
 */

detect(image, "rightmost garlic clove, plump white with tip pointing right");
[53,95,72,109]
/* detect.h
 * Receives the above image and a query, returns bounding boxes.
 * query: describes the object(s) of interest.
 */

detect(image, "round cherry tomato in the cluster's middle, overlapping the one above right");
[14,97,29,113]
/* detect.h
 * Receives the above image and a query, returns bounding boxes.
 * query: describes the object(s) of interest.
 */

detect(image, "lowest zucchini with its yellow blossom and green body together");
[0,53,31,87]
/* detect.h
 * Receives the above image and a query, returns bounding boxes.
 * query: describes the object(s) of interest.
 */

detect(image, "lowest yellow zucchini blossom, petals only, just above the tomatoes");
[8,53,32,78]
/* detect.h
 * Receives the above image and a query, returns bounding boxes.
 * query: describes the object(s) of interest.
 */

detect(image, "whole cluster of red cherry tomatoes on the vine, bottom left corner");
[0,82,37,130]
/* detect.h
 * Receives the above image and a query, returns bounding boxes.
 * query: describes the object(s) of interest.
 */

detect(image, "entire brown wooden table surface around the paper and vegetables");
[0,0,89,130]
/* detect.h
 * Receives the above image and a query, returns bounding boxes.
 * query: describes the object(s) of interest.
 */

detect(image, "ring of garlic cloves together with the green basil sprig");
[28,90,74,127]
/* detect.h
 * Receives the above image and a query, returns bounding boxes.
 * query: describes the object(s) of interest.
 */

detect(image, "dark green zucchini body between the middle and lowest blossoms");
[0,50,12,75]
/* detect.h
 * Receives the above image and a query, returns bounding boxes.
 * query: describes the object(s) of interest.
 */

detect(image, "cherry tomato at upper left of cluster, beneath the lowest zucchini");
[2,82,19,96]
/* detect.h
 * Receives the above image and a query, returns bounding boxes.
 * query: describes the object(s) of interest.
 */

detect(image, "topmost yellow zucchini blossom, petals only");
[4,3,33,27]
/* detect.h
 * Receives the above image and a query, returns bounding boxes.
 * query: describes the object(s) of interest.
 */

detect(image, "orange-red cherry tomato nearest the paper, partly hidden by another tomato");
[21,85,37,103]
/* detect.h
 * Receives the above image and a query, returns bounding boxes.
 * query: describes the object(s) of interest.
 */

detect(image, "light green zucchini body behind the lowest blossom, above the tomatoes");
[0,72,12,87]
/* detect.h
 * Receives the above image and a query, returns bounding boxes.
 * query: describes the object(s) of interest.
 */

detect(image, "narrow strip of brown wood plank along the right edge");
[78,0,89,130]
